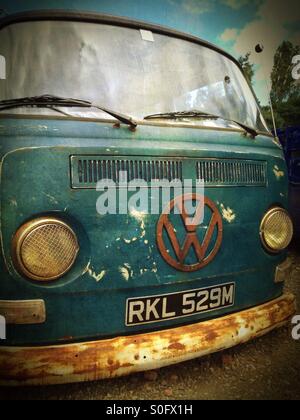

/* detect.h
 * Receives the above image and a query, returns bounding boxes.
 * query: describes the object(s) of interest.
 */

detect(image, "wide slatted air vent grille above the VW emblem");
[71,155,267,189]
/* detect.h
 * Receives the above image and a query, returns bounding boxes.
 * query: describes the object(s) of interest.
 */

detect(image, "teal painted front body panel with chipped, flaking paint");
[0,117,288,345]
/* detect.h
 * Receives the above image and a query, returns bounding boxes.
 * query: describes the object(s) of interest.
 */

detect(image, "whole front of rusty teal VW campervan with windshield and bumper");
[0,10,295,386]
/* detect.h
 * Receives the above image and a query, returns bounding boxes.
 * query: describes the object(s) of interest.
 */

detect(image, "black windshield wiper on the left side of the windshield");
[0,95,137,128]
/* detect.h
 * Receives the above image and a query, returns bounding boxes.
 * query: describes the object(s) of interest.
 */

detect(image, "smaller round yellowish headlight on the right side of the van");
[260,207,294,252]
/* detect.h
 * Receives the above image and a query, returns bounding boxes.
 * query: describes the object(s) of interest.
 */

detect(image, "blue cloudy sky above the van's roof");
[0,0,300,104]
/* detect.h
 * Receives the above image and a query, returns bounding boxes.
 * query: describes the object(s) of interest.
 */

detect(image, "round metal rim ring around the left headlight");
[12,216,80,283]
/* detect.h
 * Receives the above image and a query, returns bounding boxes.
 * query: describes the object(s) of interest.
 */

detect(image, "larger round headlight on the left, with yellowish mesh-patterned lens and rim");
[13,218,79,281]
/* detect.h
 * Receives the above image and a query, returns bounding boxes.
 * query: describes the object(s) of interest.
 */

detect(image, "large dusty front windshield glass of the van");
[0,21,267,131]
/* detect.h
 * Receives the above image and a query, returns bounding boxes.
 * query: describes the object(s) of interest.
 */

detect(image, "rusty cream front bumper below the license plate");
[0,294,295,386]
